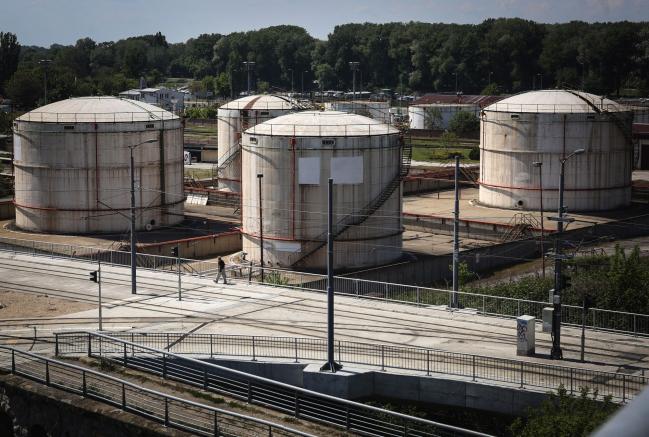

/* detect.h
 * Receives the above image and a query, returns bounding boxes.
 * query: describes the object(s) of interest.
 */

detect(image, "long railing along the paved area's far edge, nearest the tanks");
[0,237,649,336]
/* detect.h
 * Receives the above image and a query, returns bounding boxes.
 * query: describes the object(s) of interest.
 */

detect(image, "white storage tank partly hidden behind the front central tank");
[217,95,304,193]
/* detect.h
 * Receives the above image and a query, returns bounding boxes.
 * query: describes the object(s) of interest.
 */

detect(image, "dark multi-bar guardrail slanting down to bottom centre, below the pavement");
[56,332,486,437]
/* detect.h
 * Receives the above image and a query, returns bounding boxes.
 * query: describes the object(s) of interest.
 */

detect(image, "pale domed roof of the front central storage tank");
[245,111,399,137]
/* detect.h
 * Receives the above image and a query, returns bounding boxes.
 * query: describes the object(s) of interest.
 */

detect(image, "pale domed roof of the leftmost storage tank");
[18,96,179,123]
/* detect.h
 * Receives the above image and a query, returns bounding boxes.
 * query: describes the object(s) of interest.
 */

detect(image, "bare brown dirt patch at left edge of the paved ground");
[0,288,95,320]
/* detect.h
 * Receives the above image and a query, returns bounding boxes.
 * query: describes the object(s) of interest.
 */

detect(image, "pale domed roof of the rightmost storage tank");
[484,90,628,114]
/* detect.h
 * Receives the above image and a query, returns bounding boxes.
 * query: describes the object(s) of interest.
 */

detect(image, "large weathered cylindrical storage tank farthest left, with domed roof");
[14,97,184,234]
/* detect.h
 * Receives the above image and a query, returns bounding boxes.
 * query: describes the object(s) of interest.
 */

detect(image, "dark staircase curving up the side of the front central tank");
[291,137,412,267]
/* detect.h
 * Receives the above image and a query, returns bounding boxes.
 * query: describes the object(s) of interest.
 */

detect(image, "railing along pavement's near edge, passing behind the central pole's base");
[60,332,648,402]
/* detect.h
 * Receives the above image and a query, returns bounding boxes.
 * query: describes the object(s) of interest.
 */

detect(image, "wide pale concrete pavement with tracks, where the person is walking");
[0,252,649,374]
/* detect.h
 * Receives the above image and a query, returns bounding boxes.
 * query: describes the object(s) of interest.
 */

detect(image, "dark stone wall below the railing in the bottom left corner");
[0,375,190,437]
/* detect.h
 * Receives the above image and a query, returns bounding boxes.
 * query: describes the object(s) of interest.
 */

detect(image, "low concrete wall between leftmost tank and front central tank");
[138,231,242,259]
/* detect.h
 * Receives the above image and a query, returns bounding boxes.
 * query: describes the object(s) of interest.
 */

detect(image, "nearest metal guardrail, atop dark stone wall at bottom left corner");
[0,346,311,437]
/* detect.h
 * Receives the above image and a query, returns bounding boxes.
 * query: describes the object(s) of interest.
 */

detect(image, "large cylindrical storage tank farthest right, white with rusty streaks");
[480,90,633,211]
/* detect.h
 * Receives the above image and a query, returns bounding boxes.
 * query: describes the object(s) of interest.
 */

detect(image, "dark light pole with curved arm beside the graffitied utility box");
[550,149,584,359]
